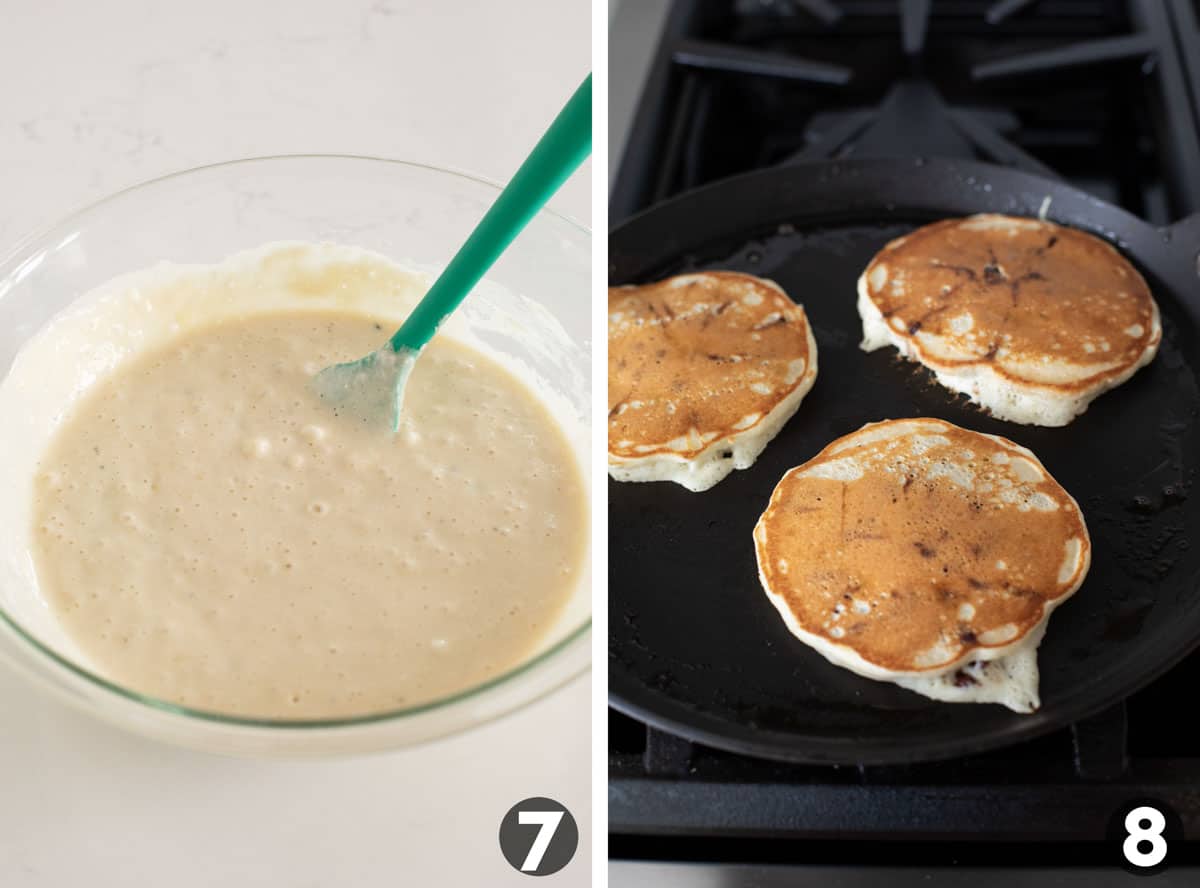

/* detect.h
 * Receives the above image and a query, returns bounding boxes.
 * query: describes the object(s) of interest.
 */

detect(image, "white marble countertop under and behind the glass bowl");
[0,0,592,888]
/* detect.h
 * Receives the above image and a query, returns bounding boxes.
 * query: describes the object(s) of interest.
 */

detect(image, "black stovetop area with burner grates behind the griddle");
[610,0,1200,223]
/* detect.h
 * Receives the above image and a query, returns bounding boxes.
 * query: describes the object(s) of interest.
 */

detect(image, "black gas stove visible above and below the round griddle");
[608,0,1200,866]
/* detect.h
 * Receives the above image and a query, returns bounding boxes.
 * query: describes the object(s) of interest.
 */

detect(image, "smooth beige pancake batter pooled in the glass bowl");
[25,252,586,719]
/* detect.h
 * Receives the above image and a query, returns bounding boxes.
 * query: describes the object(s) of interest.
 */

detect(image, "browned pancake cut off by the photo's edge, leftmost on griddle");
[608,271,817,491]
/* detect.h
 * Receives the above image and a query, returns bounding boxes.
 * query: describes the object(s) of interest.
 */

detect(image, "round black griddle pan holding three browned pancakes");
[608,158,1200,763]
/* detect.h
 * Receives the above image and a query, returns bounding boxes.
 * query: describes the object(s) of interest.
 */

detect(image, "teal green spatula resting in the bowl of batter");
[313,74,592,431]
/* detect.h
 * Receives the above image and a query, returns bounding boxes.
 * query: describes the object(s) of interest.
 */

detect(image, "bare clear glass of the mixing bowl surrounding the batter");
[0,156,590,757]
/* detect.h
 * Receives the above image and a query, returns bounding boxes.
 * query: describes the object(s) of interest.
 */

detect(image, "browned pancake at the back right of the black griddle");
[858,215,1163,426]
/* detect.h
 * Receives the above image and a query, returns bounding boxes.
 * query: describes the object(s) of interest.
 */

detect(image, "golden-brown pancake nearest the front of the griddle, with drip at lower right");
[754,419,1091,712]
